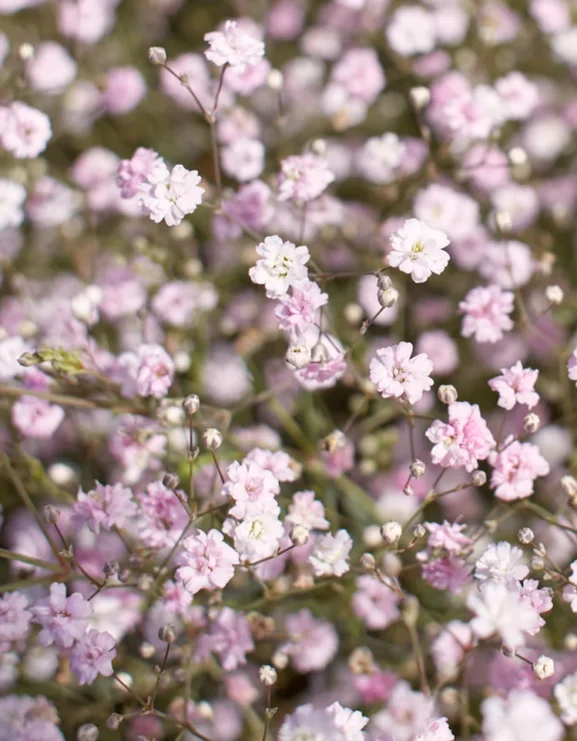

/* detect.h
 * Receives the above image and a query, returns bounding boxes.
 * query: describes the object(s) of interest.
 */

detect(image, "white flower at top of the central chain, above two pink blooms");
[249,236,310,298]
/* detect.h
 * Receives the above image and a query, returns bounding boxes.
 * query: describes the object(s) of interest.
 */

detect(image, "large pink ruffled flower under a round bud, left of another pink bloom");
[425,401,495,472]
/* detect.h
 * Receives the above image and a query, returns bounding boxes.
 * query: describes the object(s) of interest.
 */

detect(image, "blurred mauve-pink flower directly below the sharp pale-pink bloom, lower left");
[195,607,254,672]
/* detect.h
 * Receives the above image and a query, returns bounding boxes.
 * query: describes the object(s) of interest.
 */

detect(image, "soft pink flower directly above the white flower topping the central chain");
[278,152,335,203]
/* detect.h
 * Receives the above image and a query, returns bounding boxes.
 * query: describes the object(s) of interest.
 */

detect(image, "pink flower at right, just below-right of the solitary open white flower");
[459,285,515,342]
